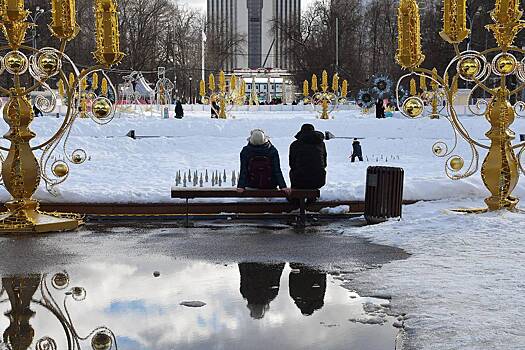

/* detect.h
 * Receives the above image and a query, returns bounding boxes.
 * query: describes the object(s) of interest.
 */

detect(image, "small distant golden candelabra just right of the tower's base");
[303,70,348,119]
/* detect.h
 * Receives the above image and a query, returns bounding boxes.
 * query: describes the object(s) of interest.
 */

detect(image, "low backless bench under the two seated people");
[171,188,321,227]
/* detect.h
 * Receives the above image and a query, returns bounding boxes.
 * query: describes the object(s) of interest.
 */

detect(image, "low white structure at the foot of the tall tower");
[227,68,296,103]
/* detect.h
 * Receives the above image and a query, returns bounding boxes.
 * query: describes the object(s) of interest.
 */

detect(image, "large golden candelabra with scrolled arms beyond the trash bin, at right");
[396,0,525,212]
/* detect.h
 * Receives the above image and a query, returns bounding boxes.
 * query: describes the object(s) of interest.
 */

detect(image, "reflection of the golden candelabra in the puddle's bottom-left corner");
[0,272,116,350]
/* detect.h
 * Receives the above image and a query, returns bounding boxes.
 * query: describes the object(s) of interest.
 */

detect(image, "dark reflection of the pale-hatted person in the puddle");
[239,263,284,319]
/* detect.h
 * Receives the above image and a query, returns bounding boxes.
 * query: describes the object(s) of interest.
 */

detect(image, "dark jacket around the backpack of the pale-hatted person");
[237,142,286,188]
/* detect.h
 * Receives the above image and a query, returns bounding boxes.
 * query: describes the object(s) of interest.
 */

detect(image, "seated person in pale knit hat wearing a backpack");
[237,129,289,192]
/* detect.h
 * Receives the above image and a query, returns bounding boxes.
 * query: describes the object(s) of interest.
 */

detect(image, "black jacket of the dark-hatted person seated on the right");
[289,131,327,189]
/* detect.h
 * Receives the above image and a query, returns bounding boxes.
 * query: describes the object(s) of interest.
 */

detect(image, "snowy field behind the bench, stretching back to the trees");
[5,110,525,203]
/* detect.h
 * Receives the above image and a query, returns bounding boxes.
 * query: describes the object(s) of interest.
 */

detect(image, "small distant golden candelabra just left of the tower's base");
[199,71,246,119]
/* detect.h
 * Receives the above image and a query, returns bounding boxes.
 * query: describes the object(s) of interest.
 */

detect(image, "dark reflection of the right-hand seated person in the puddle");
[288,264,326,316]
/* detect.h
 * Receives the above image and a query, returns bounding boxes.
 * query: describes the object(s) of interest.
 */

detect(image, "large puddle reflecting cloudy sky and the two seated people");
[0,259,397,350]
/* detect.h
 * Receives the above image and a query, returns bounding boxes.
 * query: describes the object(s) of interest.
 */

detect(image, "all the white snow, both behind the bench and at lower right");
[4,107,525,350]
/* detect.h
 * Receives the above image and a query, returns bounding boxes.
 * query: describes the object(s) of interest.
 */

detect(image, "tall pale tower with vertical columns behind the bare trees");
[207,0,301,71]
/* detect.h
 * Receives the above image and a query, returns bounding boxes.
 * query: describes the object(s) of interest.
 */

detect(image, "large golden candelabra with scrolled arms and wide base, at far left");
[0,0,123,233]
